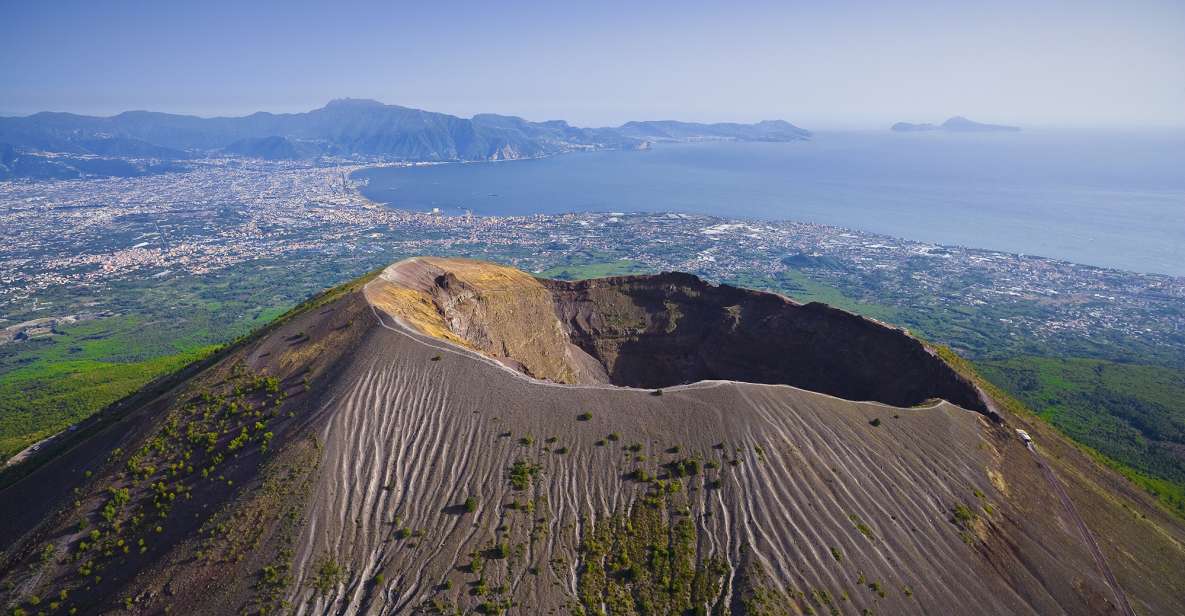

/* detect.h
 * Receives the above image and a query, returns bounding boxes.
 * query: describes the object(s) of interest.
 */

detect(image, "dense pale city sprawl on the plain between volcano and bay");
[0,159,1185,360]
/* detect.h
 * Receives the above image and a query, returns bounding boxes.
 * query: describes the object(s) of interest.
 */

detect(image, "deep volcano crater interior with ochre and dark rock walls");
[376,257,989,413]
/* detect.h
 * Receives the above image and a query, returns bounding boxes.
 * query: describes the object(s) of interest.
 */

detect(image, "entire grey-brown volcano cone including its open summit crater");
[0,258,1185,615]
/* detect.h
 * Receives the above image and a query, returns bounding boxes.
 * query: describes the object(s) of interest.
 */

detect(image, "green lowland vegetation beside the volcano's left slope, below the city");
[0,255,387,461]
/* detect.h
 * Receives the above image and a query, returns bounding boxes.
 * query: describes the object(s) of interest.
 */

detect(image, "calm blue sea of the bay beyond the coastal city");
[356,130,1185,276]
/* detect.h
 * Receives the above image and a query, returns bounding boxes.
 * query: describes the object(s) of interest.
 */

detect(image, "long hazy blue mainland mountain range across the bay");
[0,98,809,170]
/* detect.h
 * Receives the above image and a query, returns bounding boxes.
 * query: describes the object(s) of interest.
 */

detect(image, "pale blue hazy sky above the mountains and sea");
[0,0,1185,128]
